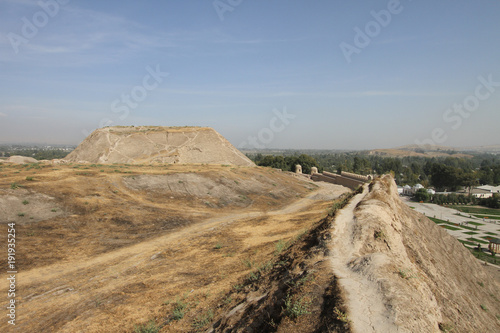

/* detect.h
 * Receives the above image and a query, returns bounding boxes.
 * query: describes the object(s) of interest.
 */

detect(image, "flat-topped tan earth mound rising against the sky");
[65,126,254,166]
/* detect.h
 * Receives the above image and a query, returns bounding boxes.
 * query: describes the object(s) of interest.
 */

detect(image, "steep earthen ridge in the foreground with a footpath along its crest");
[206,176,500,333]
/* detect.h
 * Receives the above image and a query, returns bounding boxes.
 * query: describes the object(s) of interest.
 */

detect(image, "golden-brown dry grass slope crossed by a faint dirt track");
[0,164,348,332]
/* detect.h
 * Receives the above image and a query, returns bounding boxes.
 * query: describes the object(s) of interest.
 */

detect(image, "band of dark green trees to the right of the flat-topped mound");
[247,152,500,191]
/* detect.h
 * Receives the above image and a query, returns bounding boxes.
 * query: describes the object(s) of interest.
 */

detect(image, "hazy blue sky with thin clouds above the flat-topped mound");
[0,0,500,149]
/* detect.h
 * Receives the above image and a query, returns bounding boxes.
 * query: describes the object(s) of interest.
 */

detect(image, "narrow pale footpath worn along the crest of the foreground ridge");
[331,186,398,333]
